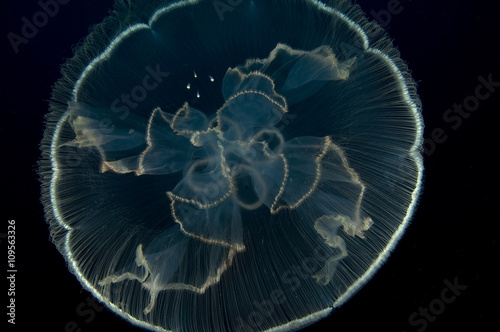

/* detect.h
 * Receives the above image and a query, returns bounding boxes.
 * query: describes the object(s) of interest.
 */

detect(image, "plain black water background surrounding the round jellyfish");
[0,0,500,332]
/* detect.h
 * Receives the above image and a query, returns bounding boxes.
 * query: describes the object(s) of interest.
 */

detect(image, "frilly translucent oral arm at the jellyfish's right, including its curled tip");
[271,137,373,285]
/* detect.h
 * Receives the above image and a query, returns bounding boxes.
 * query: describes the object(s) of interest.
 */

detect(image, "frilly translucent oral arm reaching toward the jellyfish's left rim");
[66,103,208,175]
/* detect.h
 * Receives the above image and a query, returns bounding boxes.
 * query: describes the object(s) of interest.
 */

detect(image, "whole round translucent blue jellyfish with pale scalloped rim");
[40,0,423,331]
